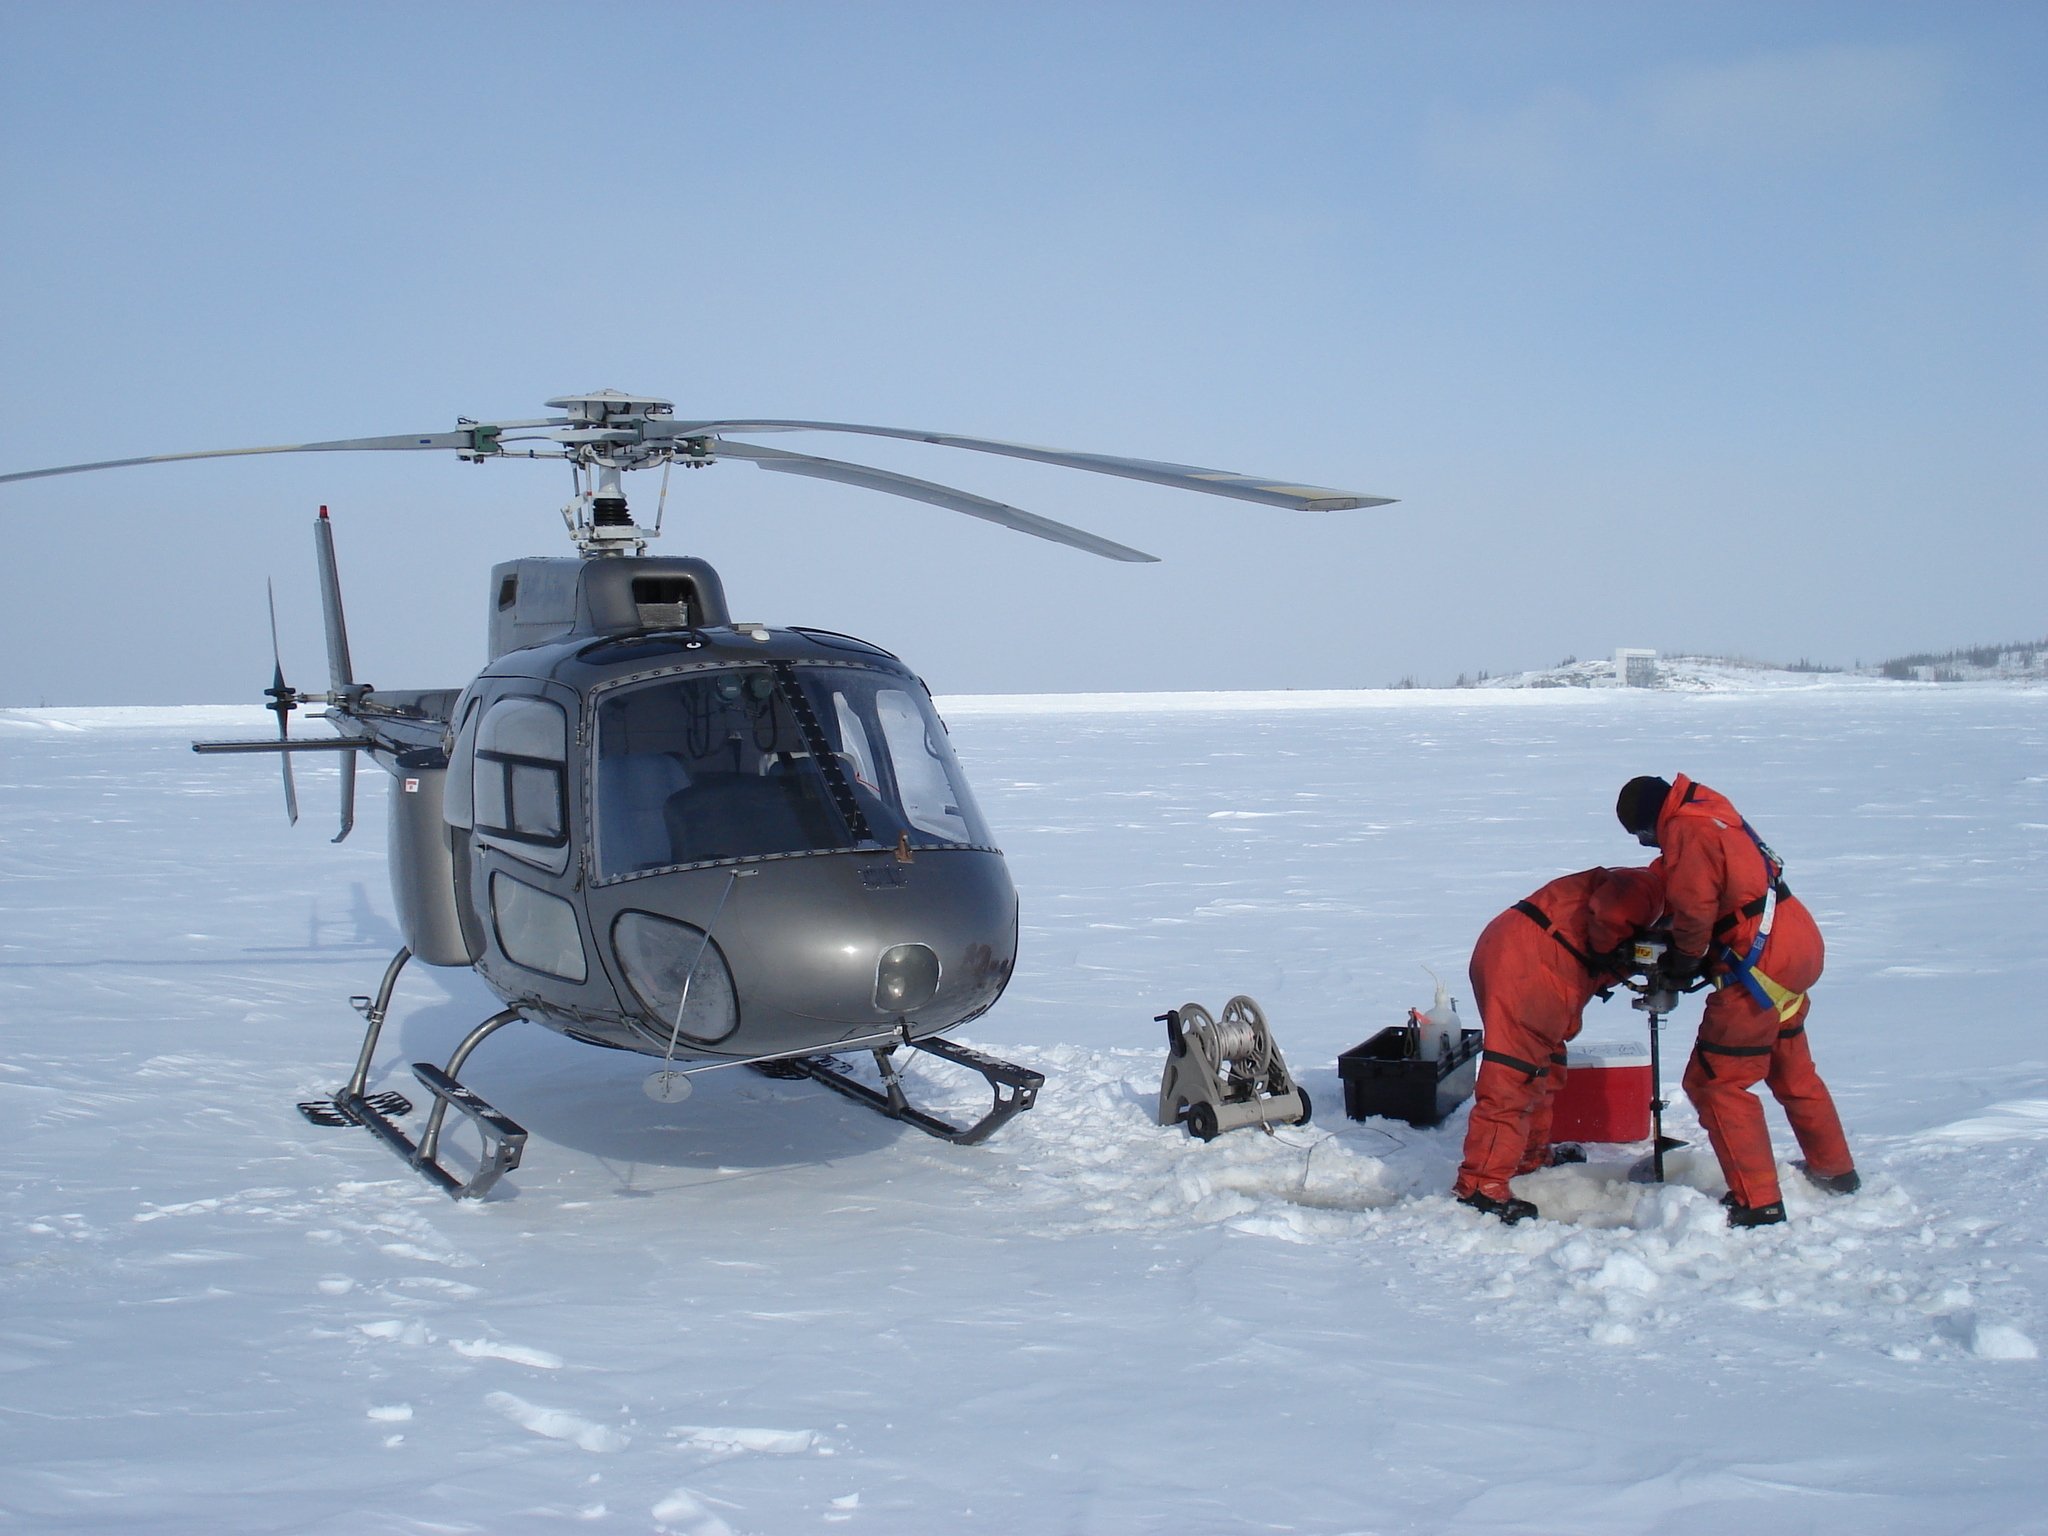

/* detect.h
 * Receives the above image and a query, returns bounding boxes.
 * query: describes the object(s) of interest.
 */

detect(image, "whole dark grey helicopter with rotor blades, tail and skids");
[0,389,1393,1198]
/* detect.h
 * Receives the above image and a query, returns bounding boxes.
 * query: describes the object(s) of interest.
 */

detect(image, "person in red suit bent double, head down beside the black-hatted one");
[1454,868,1663,1227]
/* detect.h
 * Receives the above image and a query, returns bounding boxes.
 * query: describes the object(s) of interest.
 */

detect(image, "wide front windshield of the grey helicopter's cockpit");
[596,664,989,879]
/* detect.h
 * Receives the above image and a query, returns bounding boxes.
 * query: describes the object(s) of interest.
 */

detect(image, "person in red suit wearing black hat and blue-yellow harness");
[1614,774,1862,1227]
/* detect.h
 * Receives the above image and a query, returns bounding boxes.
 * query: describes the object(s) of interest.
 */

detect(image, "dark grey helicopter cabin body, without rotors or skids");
[367,555,1018,1061]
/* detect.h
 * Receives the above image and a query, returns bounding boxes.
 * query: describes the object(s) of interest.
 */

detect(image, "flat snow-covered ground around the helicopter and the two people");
[0,680,2048,1536]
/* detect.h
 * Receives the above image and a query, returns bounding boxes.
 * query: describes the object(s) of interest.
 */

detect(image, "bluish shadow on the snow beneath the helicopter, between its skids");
[369,971,920,1200]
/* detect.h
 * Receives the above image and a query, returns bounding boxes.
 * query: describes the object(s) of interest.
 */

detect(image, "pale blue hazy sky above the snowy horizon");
[0,0,2048,705]
